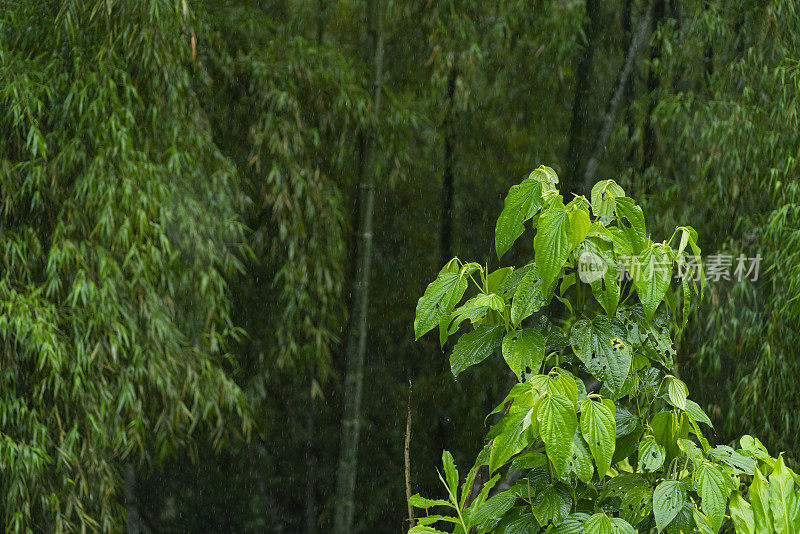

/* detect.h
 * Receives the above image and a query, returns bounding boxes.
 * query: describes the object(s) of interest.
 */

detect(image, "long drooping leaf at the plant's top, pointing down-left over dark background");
[494,173,545,258]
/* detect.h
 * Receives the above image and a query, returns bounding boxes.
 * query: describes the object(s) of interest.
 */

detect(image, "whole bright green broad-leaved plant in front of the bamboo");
[409,166,800,534]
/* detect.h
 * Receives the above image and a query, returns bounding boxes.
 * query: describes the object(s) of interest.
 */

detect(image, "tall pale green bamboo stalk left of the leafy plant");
[334,0,383,534]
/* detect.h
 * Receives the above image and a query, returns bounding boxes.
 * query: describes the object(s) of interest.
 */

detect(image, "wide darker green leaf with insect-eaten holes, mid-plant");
[570,315,631,398]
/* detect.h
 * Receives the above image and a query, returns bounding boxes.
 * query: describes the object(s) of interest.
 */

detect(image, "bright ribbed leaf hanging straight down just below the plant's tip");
[533,203,572,298]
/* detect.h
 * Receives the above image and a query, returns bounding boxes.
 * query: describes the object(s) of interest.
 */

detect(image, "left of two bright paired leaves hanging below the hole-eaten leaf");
[537,394,578,476]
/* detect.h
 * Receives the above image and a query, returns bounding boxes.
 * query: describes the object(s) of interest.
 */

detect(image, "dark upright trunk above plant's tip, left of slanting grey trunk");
[562,0,601,197]
